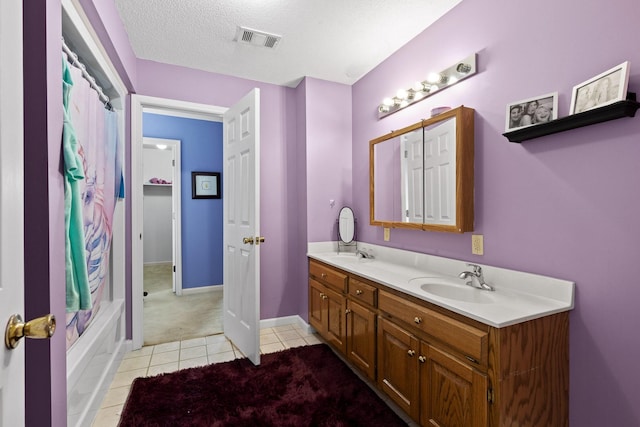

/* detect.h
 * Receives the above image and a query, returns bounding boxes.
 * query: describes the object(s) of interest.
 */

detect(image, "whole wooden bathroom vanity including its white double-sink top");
[308,244,575,427]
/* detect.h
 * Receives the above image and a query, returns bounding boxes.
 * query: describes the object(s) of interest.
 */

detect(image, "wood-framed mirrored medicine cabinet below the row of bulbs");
[369,106,474,233]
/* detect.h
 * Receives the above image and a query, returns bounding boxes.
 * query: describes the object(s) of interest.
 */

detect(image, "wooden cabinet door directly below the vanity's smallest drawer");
[347,301,376,380]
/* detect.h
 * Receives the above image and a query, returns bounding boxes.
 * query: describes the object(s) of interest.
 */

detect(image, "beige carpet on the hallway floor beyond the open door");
[143,264,223,345]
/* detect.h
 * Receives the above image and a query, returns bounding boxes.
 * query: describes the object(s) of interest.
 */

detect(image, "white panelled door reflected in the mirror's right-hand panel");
[424,118,456,225]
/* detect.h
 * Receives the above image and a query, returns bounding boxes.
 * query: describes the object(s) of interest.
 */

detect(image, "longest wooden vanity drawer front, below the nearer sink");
[378,290,488,363]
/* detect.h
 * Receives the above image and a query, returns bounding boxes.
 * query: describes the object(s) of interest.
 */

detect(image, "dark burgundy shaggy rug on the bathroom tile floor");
[119,344,407,427]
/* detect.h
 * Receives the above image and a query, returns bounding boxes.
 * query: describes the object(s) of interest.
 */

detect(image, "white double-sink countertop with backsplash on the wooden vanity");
[307,242,575,328]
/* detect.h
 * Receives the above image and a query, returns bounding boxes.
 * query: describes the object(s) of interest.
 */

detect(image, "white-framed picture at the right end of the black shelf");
[569,61,629,114]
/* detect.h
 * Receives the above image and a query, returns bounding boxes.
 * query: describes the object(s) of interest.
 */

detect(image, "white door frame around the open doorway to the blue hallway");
[131,94,228,350]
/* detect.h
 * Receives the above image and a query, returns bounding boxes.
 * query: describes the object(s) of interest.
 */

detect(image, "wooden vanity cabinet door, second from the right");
[378,317,420,421]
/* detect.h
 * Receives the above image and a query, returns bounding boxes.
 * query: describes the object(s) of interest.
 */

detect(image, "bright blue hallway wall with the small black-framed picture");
[143,113,224,289]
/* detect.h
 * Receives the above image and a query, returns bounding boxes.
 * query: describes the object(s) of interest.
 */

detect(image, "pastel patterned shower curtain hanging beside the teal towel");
[63,55,122,349]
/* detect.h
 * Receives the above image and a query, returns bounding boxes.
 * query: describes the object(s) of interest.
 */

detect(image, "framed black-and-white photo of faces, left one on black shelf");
[505,92,558,132]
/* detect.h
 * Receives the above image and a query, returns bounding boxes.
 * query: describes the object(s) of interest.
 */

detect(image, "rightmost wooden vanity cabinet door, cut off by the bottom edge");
[420,343,489,427]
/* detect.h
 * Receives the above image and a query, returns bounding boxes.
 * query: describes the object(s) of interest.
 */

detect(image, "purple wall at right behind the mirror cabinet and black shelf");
[353,0,640,427]
